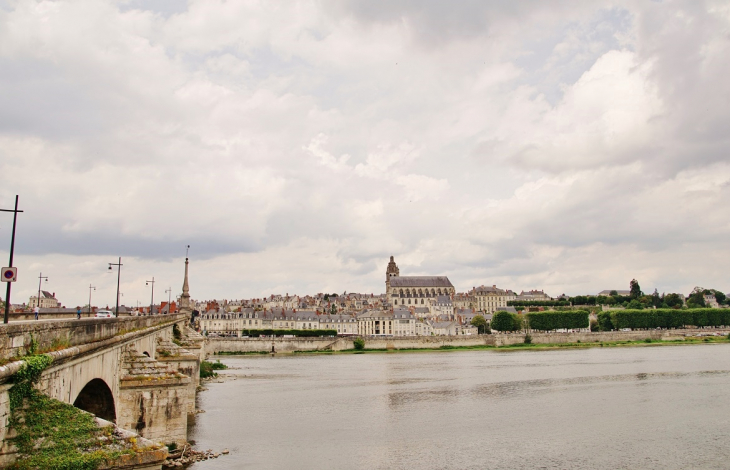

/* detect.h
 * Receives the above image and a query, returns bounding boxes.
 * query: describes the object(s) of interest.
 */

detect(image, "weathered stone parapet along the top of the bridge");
[0,314,188,362]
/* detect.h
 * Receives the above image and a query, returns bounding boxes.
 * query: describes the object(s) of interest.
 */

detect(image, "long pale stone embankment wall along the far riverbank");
[205,328,730,355]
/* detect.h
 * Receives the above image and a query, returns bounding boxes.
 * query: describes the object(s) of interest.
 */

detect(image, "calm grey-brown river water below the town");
[189,344,730,470]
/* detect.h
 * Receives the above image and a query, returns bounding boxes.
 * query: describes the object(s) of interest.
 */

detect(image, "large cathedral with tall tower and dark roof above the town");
[385,256,455,307]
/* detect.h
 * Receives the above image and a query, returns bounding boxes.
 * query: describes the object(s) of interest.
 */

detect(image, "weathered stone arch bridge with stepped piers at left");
[0,314,204,464]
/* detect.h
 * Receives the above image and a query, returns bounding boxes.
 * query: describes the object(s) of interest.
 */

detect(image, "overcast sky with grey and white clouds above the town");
[0,0,730,307]
